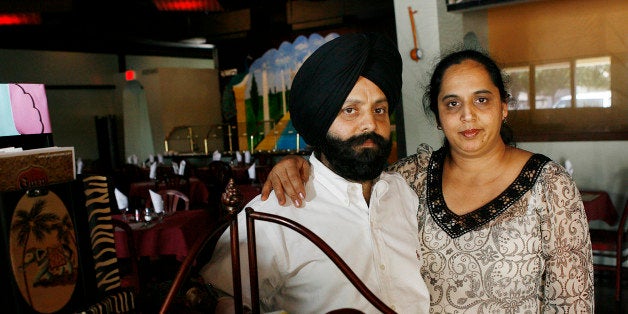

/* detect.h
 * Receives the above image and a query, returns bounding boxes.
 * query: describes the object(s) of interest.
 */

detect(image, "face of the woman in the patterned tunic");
[438,60,508,155]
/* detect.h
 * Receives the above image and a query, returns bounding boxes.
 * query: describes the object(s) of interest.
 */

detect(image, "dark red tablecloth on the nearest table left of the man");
[114,209,215,261]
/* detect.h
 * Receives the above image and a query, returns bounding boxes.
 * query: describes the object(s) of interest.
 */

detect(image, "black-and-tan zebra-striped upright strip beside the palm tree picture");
[83,175,138,313]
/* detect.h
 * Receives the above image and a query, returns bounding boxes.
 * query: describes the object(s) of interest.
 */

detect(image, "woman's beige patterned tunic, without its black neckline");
[390,144,594,313]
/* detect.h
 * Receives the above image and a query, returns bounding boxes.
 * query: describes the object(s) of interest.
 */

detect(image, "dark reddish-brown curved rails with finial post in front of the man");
[160,179,395,314]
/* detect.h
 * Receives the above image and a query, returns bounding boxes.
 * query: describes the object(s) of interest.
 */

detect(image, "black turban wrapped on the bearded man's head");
[288,33,402,147]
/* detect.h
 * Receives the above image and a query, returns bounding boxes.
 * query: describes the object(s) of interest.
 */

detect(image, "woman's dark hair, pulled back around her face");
[423,49,515,146]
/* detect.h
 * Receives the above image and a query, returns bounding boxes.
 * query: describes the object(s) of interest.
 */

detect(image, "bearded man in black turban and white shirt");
[202,33,429,313]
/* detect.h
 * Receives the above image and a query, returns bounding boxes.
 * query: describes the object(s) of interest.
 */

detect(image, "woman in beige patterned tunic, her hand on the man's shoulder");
[264,50,594,313]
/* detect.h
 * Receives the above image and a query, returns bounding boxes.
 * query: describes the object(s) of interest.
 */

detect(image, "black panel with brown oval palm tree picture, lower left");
[0,182,94,313]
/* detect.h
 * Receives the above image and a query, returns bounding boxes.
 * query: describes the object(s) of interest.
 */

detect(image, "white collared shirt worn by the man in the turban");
[202,155,429,313]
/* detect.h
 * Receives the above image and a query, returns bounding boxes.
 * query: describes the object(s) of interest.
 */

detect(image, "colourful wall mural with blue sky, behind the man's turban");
[223,33,338,151]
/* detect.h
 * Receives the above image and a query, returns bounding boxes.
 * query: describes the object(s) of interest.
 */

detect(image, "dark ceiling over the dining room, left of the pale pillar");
[0,0,395,67]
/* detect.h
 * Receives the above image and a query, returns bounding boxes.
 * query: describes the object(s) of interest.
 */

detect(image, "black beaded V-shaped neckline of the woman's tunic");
[427,148,550,238]
